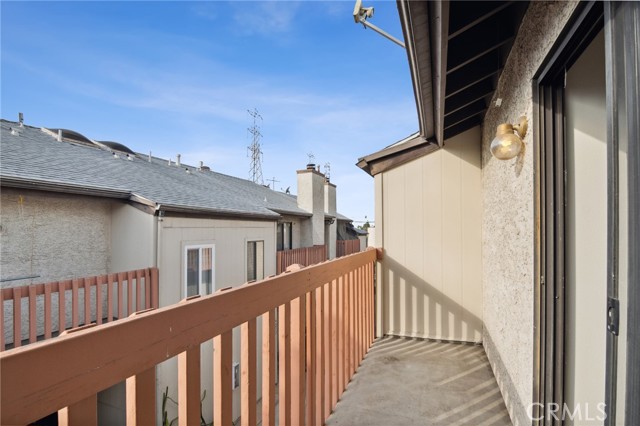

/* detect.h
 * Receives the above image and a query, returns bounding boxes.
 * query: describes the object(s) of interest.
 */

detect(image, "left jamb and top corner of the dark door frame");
[532,1,604,425]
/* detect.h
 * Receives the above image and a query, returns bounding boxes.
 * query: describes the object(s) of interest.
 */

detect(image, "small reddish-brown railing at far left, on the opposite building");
[0,268,158,351]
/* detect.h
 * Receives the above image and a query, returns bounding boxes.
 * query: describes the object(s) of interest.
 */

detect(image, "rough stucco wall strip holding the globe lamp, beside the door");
[482,1,577,425]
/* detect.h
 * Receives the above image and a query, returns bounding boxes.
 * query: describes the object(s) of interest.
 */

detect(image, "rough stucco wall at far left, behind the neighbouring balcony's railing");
[0,188,115,343]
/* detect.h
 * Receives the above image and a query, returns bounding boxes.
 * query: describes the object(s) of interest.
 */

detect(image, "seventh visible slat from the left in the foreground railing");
[278,303,291,426]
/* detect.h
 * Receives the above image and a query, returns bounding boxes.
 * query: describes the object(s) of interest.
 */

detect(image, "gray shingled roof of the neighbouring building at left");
[0,120,310,219]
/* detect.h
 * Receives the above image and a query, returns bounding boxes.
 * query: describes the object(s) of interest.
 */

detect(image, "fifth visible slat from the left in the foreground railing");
[240,318,258,426]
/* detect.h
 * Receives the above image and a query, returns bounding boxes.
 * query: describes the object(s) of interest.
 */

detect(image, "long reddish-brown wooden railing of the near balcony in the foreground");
[0,249,378,426]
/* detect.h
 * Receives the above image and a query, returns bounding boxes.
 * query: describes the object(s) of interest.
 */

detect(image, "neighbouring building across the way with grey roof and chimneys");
[0,120,350,423]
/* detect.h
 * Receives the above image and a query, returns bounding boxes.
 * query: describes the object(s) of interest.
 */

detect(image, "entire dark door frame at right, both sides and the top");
[532,1,640,425]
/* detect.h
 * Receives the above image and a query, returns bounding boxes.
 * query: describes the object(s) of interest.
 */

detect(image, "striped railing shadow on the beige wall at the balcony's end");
[382,257,482,342]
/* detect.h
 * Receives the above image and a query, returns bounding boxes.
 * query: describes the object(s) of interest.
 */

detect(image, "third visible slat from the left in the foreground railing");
[178,345,200,426]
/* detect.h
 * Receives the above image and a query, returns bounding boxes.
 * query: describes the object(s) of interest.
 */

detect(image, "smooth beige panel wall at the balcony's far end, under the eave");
[376,128,482,342]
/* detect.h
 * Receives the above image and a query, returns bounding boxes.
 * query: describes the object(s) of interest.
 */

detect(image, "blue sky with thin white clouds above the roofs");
[1,0,418,225]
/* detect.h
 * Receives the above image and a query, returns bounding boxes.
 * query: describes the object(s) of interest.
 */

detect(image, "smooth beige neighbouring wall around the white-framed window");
[156,217,276,421]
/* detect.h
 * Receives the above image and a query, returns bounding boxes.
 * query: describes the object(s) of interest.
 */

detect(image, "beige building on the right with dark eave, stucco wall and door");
[358,0,640,425]
